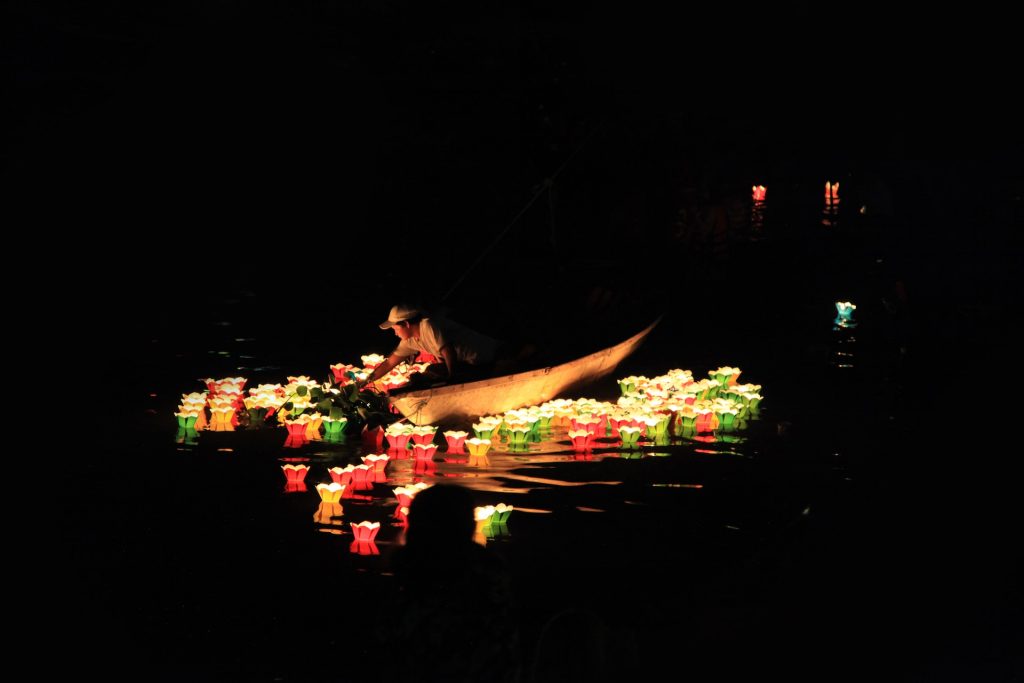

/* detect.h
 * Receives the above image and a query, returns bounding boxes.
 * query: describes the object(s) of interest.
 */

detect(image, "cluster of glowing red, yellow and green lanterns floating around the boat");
[175,360,765,555]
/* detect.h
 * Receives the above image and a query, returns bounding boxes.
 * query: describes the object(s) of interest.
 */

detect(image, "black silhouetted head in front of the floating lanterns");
[406,484,476,546]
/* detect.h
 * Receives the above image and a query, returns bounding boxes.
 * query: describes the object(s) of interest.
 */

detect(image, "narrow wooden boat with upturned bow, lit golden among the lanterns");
[389,317,662,425]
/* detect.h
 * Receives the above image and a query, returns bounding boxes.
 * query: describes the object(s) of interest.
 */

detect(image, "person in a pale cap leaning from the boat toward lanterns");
[364,304,512,390]
